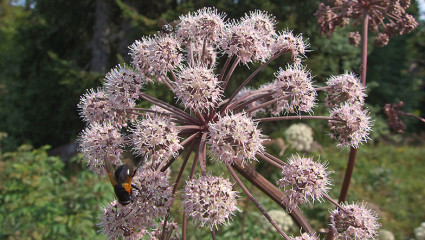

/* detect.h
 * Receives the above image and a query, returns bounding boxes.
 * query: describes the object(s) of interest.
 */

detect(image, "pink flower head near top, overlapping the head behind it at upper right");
[220,19,271,64]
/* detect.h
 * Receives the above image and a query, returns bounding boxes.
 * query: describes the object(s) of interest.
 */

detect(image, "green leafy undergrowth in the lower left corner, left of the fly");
[0,145,113,239]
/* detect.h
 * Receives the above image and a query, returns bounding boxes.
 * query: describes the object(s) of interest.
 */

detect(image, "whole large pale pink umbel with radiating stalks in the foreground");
[78,8,377,239]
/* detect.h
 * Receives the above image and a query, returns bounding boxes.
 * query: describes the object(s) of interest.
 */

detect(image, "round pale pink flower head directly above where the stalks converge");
[174,66,223,112]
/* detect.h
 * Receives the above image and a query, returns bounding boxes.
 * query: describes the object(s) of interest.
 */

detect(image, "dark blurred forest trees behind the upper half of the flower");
[0,0,425,149]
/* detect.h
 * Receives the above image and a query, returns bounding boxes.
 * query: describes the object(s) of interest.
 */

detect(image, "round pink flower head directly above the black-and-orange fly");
[78,122,124,174]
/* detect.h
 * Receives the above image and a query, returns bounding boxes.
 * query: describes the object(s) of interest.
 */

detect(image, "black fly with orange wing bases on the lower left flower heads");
[103,159,140,206]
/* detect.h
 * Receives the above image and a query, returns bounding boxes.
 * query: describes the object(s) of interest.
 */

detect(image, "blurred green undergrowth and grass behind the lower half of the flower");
[0,145,425,240]
